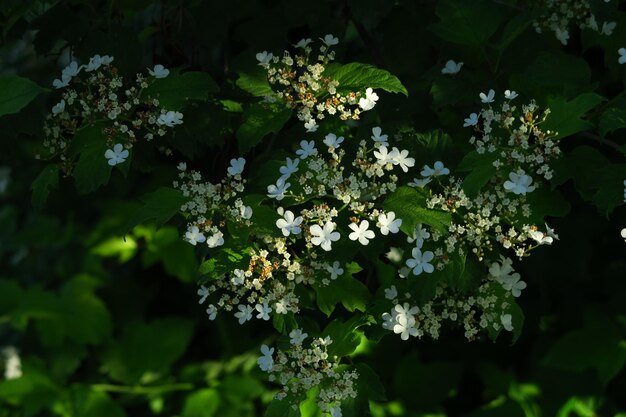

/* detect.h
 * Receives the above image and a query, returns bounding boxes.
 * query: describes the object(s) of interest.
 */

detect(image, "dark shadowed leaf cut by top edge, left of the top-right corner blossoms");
[429,0,504,46]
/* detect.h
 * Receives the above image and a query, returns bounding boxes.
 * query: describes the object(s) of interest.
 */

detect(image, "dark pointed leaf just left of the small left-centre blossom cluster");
[126,187,189,232]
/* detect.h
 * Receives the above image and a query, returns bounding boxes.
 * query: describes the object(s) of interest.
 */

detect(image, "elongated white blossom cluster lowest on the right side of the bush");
[382,257,526,341]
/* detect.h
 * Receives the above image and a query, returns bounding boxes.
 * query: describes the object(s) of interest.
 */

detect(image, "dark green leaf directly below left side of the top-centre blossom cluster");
[236,103,291,154]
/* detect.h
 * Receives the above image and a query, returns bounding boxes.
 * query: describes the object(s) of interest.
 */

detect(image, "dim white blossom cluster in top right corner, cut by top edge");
[533,0,617,45]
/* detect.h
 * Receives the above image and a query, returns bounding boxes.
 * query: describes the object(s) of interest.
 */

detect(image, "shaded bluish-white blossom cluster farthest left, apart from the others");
[43,55,183,173]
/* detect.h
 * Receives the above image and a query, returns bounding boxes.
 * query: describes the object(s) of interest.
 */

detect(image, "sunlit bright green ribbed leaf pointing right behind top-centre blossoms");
[324,62,409,96]
